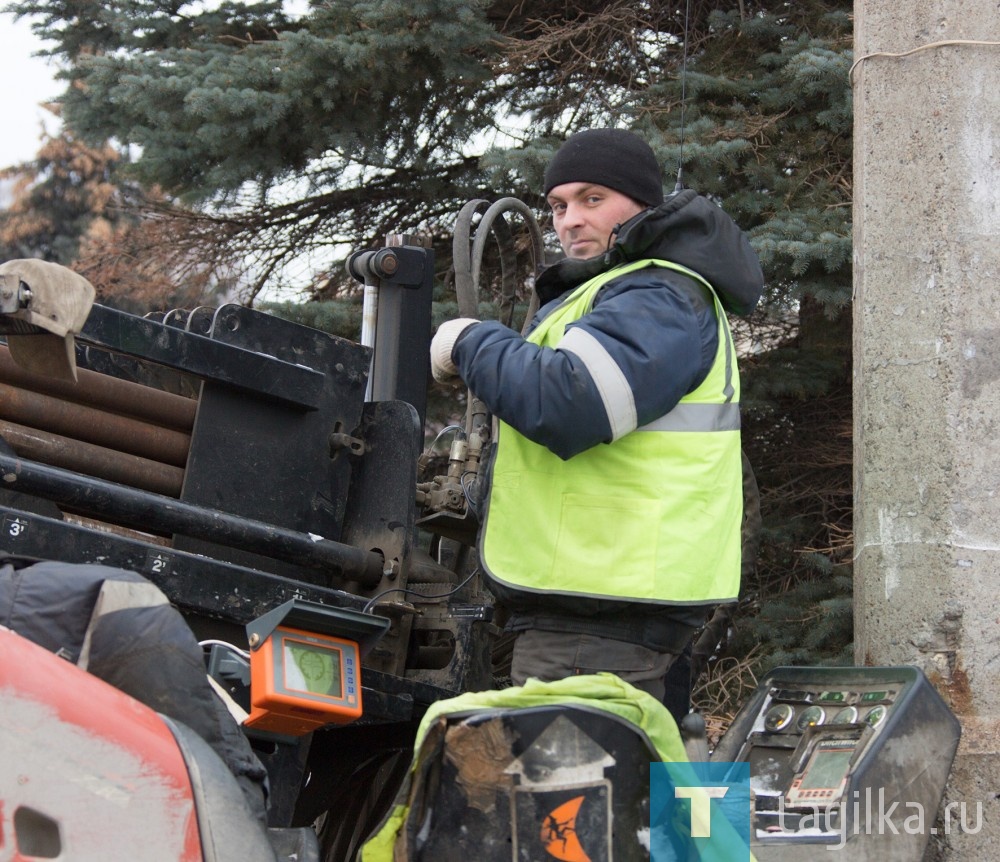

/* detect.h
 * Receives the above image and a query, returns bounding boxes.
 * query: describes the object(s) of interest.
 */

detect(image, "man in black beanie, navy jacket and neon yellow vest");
[431,129,763,698]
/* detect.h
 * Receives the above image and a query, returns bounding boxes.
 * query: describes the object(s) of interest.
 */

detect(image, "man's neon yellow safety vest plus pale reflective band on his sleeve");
[480,260,743,604]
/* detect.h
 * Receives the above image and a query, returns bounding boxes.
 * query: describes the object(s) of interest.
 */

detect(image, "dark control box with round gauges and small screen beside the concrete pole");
[712,667,960,860]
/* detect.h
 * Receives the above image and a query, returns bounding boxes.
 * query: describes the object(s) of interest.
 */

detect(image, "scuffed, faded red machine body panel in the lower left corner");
[0,627,204,862]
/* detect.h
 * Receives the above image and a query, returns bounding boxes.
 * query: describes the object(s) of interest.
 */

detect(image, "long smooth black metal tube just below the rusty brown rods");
[0,453,389,588]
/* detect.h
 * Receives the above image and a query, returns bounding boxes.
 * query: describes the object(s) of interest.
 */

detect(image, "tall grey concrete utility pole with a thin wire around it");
[853,0,1000,862]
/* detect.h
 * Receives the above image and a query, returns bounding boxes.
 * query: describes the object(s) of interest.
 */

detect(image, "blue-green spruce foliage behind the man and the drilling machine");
[8,0,852,712]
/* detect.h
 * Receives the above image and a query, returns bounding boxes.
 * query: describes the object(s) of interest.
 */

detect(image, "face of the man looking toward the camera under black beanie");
[546,183,646,260]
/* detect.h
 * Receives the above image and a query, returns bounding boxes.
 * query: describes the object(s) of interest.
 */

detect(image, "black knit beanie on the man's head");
[545,129,663,206]
